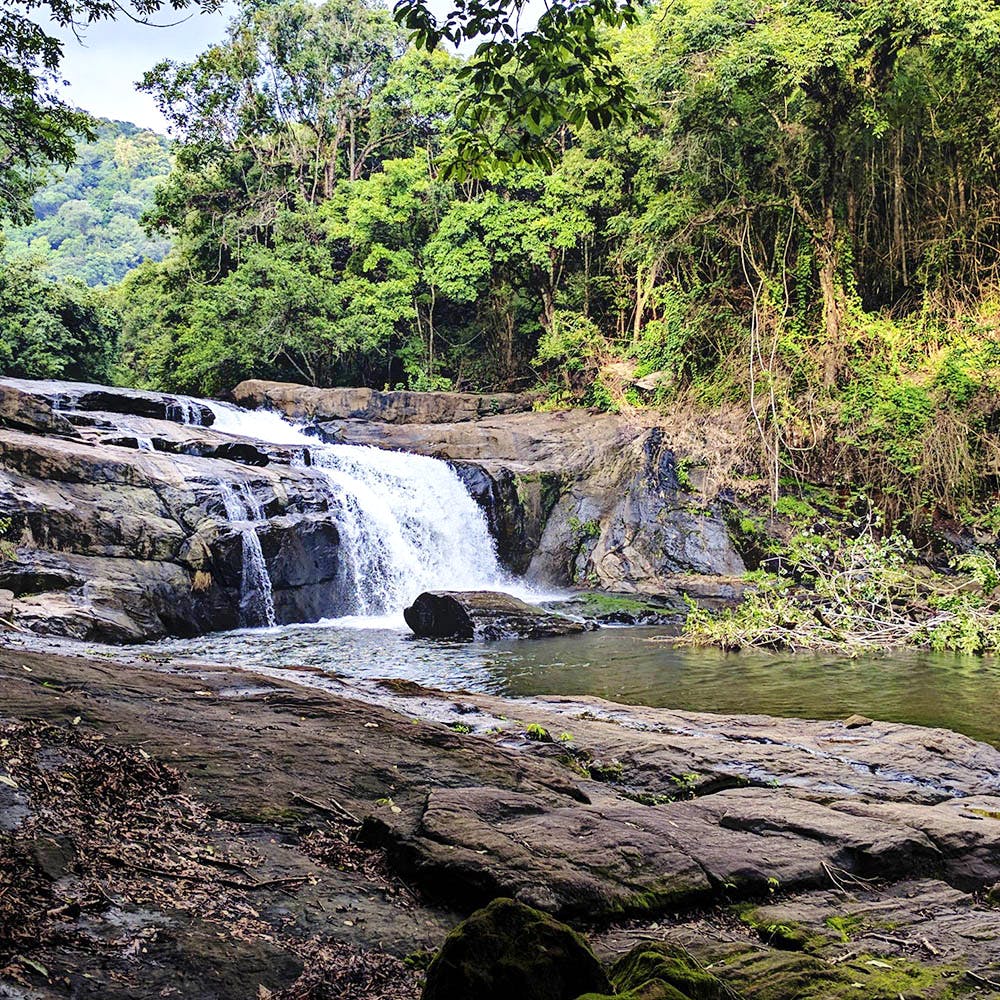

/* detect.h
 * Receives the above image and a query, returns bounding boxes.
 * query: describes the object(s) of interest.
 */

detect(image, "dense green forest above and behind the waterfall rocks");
[0,0,1000,529]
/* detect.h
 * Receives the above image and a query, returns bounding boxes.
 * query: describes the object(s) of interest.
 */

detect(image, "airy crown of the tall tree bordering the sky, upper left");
[142,0,405,205]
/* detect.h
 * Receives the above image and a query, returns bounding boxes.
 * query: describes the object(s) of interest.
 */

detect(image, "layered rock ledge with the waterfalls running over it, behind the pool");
[0,379,743,642]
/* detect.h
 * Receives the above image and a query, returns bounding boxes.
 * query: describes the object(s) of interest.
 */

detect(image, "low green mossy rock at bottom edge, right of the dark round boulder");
[579,943,735,1000]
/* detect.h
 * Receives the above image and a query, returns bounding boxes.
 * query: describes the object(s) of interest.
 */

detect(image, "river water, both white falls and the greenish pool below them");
[23,382,1000,746]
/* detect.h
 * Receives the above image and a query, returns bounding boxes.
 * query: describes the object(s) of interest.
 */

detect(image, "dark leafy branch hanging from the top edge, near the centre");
[394,0,644,173]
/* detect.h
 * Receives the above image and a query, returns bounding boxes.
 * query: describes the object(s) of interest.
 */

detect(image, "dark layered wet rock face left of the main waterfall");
[0,380,345,642]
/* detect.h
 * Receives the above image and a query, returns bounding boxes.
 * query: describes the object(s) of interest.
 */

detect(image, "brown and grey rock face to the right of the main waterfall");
[233,381,745,594]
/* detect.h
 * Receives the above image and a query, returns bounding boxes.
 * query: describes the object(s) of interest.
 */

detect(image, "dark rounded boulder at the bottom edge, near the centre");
[423,899,612,1000]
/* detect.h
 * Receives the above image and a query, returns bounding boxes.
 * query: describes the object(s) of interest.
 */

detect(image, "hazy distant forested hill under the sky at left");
[4,121,172,286]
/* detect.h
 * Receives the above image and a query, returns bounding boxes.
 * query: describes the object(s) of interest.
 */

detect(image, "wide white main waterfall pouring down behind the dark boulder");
[210,403,517,617]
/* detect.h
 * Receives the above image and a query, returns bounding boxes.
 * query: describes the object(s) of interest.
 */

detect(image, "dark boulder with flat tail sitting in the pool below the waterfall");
[403,590,589,640]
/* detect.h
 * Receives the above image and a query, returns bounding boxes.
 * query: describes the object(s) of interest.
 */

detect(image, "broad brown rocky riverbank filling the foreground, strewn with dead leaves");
[0,647,1000,1000]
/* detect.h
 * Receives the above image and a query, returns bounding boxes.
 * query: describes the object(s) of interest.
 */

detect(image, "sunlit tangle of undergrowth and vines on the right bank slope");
[535,296,1000,537]
